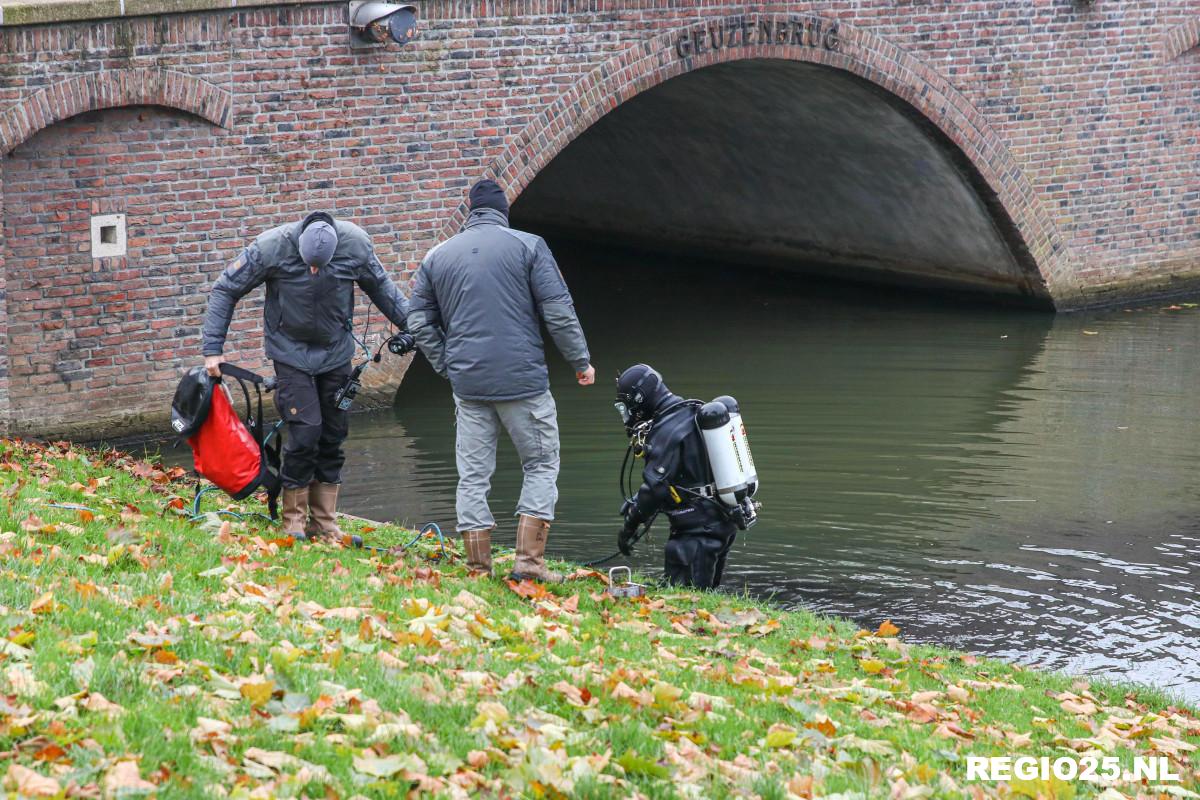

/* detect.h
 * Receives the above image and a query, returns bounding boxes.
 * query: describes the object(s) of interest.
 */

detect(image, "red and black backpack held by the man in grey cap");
[170,363,282,519]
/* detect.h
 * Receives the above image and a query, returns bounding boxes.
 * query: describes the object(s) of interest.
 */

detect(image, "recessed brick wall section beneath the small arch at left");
[2,106,253,427]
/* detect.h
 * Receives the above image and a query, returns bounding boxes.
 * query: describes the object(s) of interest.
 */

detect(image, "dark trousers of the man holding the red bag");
[275,361,350,489]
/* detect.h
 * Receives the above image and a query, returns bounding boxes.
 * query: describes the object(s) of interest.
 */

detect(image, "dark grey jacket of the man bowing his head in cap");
[203,219,408,375]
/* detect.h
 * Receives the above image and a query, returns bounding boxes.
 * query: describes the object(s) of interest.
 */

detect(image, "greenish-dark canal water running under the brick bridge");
[171,248,1200,700]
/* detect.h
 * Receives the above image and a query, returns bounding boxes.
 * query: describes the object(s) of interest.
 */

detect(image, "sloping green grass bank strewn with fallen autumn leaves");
[0,441,1200,800]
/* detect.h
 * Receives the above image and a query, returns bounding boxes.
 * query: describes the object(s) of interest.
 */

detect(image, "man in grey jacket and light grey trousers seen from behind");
[408,180,595,583]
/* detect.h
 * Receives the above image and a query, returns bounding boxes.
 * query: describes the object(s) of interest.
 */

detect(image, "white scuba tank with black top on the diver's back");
[696,396,758,530]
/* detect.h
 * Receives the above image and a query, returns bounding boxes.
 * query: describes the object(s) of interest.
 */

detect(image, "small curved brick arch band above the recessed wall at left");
[0,68,233,156]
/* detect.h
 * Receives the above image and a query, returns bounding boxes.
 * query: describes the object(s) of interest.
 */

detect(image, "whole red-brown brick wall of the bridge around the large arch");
[0,0,1200,429]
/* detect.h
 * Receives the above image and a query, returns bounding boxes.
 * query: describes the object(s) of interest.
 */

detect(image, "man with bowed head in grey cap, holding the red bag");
[204,211,408,539]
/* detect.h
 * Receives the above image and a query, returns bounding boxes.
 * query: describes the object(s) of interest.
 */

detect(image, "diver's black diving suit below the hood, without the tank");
[625,392,738,589]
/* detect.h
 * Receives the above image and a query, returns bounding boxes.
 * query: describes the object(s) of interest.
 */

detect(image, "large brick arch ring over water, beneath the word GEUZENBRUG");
[472,14,1079,302]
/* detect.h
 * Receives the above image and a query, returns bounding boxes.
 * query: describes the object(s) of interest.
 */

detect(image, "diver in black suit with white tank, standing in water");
[616,363,757,589]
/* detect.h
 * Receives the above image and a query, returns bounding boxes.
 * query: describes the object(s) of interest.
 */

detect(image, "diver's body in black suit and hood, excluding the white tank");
[617,363,738,589]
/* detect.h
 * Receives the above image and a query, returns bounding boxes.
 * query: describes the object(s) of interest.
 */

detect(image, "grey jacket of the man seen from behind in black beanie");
[408,207,590,402]
